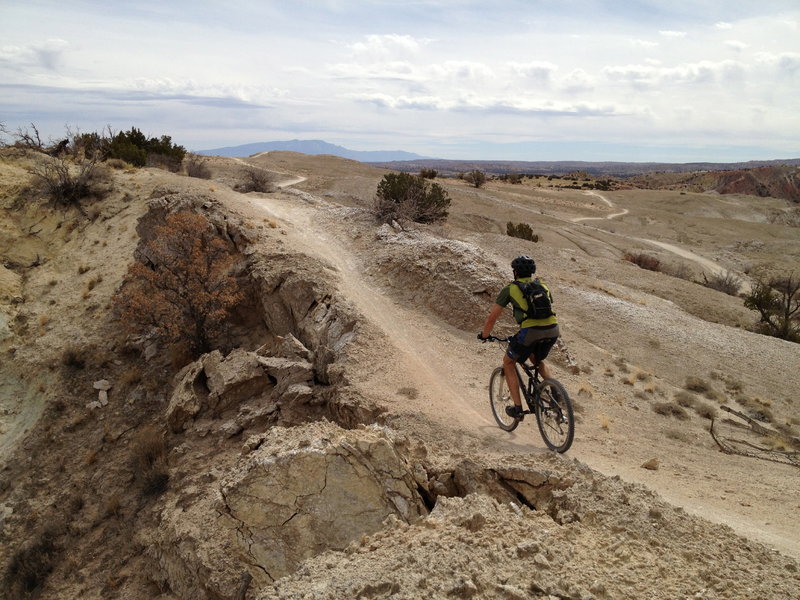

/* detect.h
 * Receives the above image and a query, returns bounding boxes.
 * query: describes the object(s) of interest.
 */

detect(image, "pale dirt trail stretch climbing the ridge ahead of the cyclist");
[216,192,516,442]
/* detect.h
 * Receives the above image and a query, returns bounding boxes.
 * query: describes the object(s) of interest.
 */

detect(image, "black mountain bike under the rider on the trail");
[486,335,575,452]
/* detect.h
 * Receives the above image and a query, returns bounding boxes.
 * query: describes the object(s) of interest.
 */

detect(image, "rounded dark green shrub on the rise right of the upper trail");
[373,173,450,223]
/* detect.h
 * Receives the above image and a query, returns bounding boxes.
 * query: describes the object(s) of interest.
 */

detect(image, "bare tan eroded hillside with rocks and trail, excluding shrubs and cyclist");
[0,153,800,599]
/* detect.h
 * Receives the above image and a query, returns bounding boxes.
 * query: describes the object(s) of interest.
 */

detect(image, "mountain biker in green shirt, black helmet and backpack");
[478,256,559,419]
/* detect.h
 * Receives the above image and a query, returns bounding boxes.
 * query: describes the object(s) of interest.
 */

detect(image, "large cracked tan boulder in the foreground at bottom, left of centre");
[140,422,427,600]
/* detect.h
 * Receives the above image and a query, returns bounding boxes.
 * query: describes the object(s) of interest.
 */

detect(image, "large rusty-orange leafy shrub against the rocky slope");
[114,212,243,357]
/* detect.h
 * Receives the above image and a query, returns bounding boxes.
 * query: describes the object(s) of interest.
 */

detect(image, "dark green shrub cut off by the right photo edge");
[744,273,800,343]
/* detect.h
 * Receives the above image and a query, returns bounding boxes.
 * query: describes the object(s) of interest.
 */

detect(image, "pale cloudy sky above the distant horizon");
[0,0,800,162]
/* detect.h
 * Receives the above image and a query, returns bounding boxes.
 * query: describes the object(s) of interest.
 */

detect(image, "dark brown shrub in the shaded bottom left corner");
[2,528,59,600]
